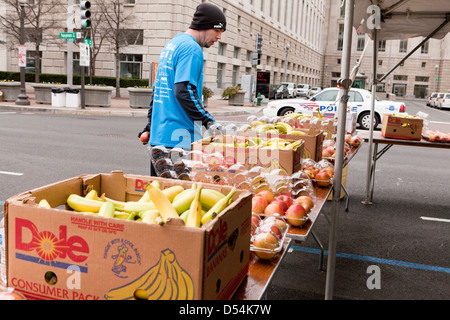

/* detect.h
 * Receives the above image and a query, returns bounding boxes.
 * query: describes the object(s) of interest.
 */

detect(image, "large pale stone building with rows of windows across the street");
[0,0,450,96]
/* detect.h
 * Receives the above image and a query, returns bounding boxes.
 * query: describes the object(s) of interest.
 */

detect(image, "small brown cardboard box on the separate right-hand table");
[381,114,423,140]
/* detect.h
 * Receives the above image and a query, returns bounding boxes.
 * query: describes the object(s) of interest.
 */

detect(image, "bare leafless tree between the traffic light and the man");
[96,0,142,97]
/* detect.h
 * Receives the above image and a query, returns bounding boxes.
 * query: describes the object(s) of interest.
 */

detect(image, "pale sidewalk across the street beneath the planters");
[0,90,263,117]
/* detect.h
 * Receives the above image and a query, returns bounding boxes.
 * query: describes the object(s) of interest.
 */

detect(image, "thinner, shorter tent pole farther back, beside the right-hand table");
[362,29,378,204]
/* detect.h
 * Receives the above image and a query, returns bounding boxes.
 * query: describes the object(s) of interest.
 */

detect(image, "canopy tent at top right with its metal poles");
[325,0,450,300]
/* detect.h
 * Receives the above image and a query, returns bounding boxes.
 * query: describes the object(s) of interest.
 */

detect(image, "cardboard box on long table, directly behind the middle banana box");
[242,128,324,161]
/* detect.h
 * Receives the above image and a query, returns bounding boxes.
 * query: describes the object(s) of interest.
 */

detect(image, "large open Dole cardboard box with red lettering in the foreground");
[4,171,251,300]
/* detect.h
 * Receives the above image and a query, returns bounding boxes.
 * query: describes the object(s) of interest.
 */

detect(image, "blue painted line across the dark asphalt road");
[291,246,450,273]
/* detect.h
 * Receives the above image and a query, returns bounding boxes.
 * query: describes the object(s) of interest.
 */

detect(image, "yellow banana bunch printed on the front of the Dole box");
[105,249,195,300]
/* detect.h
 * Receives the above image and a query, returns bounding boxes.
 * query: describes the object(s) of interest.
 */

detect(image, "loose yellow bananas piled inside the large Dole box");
[38,180,236,227]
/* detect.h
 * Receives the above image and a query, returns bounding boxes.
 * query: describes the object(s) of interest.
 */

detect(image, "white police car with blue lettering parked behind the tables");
[263,88,406,130]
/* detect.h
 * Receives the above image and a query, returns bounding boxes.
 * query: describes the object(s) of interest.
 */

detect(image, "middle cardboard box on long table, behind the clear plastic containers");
[192,136,304,175]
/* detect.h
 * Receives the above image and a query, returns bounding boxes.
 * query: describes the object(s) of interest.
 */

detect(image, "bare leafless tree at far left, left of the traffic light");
[0,0,63,82]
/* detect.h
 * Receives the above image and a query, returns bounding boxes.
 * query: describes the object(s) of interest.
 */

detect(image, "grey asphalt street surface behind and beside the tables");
[0,100,450,300]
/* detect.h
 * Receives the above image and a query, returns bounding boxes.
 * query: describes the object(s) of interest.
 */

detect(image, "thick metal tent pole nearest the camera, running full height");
[325,0,355,300]
